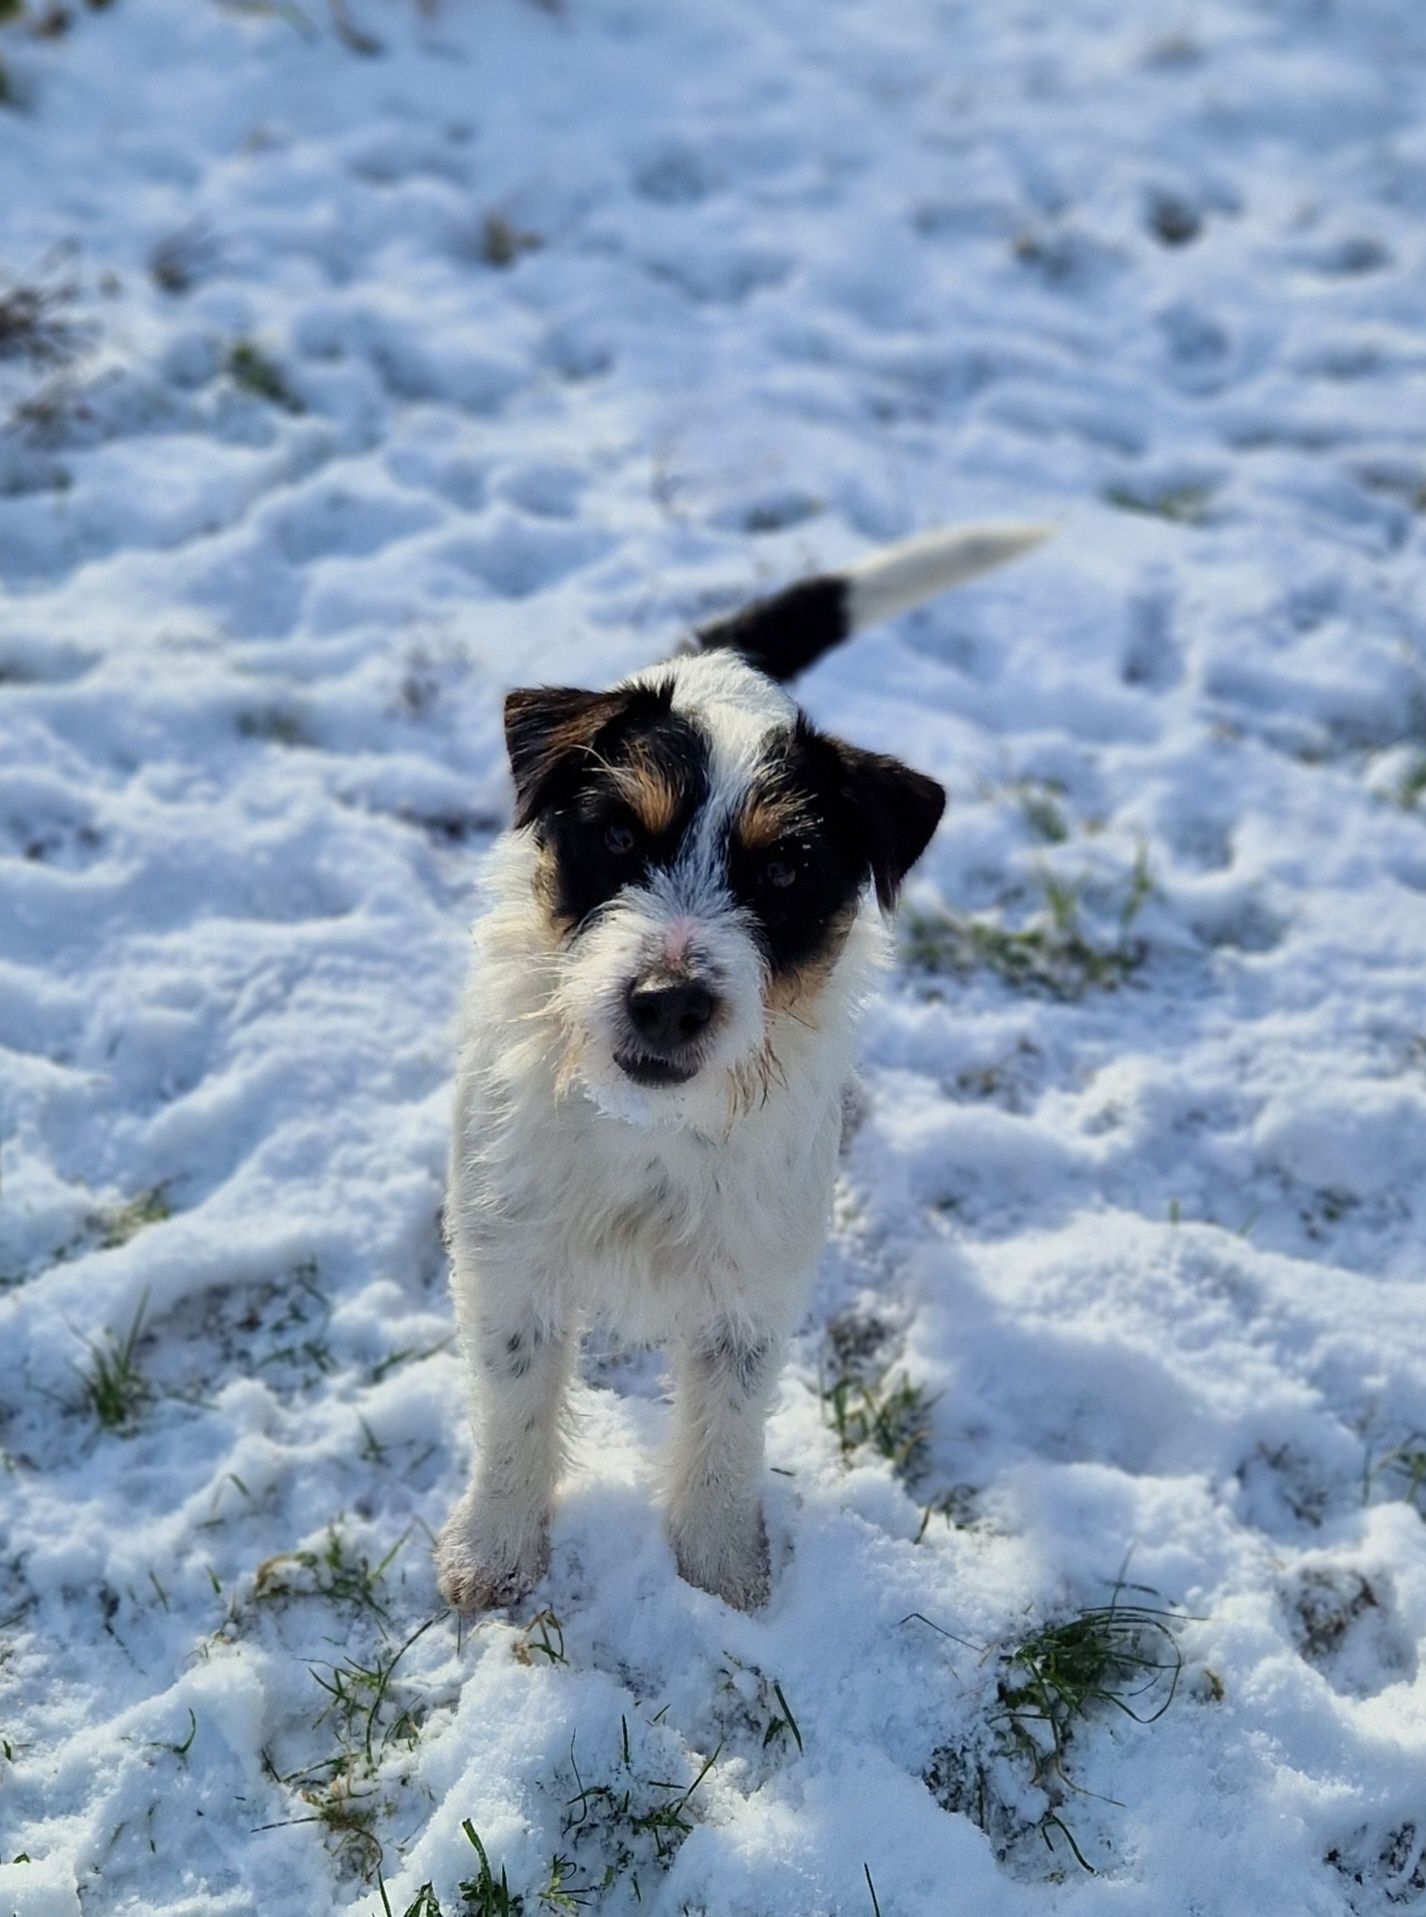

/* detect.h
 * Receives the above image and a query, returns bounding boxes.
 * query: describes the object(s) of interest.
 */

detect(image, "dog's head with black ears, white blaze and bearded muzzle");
[506,654,945,1123]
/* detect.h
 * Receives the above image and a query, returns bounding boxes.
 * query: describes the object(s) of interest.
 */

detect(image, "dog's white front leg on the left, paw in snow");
[435,1307,573,1610]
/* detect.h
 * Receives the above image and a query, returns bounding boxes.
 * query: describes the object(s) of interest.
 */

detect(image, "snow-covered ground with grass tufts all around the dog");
[0,0,1426,1917]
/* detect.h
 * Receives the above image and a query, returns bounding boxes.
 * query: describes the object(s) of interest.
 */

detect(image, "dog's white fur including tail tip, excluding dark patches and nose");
[437,529,1031,1610]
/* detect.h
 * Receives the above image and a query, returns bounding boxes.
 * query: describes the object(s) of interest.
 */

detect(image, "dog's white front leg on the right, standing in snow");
[669,1328,782,1610]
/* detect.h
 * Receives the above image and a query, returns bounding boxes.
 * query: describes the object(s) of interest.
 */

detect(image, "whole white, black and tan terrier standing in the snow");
[437,525,1047,1610]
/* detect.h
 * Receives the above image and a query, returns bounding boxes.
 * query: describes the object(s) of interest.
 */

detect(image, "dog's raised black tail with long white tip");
[694,523,1054,681]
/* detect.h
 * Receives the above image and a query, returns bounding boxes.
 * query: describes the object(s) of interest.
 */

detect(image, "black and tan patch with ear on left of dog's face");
[506,684,709,930]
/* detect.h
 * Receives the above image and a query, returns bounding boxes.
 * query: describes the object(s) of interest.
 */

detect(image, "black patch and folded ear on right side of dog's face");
[728,717,945,976]
